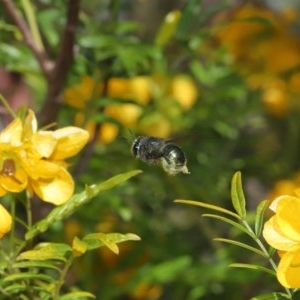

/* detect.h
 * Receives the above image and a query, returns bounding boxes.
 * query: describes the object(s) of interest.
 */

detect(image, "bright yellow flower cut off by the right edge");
[263,189,300,288]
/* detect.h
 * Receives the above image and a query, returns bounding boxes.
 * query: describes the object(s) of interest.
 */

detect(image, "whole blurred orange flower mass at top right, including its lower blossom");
[215,2,300,117]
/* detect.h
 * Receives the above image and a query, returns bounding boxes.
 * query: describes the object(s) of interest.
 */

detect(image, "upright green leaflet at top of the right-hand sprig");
[231,172,246,219]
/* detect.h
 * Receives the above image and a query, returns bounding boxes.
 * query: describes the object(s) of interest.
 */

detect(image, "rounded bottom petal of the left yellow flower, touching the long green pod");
[30,168,74,205]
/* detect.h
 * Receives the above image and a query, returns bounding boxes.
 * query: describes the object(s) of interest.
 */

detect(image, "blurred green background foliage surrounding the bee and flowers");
[0,0,300,300]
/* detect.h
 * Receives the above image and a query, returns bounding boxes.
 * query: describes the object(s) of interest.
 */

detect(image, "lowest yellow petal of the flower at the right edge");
[277,251,300,288]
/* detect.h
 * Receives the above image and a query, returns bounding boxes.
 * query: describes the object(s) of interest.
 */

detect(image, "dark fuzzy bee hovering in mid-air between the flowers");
[131,136,189,175]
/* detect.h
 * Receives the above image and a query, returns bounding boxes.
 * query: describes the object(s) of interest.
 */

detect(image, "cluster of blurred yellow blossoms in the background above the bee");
[64,75,198,143]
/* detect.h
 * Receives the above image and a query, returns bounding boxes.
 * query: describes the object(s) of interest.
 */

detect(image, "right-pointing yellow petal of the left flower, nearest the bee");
[51,126,89,160]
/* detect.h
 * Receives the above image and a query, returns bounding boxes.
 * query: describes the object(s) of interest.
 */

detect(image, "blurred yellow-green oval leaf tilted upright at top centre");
[155,10,181,46]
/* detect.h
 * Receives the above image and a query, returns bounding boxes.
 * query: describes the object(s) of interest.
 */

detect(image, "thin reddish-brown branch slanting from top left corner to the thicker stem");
[1,0,52,79]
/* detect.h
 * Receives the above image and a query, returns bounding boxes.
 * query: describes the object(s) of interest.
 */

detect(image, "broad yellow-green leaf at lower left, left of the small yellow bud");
[17,243,72,262]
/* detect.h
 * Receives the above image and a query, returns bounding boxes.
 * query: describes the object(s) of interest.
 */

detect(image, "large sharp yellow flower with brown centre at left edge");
[0,110,89,205]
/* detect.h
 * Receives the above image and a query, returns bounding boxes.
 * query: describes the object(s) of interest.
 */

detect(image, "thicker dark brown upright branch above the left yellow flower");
[40,0,81,125]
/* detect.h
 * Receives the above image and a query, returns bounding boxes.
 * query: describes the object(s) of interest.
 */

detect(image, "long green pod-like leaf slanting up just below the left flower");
[25,170,142,240]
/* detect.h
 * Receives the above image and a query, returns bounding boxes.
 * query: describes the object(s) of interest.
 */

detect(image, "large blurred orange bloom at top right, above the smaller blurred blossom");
[215,3,300,73]
